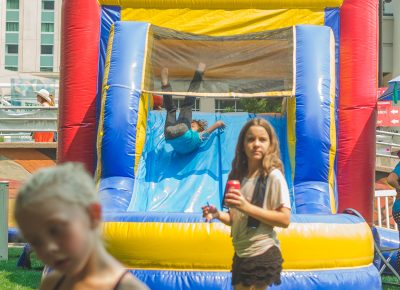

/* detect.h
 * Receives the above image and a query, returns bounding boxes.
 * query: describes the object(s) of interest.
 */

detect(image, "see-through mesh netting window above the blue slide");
[145,26,293,98]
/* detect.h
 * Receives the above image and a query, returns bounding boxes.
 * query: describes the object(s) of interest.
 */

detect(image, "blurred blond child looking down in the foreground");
[15,163,148,290]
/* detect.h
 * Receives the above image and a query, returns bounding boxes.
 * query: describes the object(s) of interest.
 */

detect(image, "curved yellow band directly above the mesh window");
[121,8,325,36]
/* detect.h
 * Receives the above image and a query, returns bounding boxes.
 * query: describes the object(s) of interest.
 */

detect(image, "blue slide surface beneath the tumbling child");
[128,111,293,212]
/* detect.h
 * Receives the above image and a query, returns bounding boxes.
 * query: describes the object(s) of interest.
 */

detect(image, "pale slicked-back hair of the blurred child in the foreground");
[14,162,98,216]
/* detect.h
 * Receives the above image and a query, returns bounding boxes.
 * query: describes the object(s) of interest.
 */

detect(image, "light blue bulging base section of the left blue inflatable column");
[99,176,135,212]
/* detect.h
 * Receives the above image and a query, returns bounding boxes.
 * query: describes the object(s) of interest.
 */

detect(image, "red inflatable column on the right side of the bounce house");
[337,0,379,223]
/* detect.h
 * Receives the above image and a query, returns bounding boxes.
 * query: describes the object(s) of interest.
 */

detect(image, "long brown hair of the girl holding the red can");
[228,118,283,180]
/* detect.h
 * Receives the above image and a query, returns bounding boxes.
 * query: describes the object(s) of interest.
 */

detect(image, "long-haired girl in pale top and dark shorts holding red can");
[202,119,290,290]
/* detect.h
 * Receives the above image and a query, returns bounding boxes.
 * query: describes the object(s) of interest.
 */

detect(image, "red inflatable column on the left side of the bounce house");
[58,0,100,172]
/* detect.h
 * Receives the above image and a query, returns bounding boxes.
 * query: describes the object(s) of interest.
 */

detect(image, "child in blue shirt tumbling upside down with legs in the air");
[161,63,225,154]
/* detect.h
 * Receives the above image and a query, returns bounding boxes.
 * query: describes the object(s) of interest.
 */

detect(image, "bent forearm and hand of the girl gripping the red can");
[225,189,290,228]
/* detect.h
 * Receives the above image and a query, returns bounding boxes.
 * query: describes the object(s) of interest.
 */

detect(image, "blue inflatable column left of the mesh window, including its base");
[96,21,149,211]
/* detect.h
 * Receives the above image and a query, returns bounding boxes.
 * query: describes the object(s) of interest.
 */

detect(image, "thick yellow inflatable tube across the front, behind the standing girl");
[103,222,374,270]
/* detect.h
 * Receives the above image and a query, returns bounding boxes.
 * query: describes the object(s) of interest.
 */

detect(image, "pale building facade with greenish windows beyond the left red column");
[0,0,62,77]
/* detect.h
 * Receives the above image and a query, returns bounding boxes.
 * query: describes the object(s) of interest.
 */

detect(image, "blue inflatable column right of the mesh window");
[288,25,337,214]
